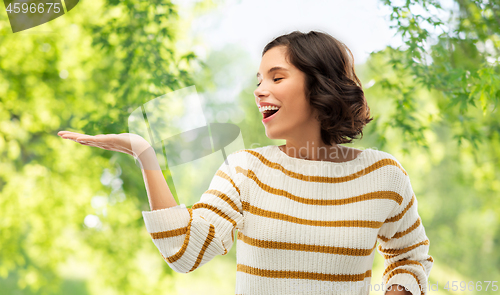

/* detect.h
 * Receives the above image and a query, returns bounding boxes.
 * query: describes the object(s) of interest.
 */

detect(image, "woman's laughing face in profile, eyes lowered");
[254,46,319,141]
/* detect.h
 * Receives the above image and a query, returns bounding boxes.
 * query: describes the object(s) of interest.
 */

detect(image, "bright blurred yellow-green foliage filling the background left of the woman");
[0,0,213,294]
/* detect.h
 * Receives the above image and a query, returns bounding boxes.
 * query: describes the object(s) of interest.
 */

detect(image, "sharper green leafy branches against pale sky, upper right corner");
[373,0,500,153]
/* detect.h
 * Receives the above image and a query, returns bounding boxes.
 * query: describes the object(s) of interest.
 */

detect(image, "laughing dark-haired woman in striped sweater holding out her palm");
[59,31,433,295]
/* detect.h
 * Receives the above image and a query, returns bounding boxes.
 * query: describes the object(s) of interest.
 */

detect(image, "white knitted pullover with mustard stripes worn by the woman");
[142,145,433,295]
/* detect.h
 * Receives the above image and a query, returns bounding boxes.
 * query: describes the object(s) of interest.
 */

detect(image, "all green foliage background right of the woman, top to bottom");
[364,0,500,294]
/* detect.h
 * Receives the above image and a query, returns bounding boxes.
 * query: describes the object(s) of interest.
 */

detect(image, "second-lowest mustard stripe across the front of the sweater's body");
[238,231,377,256]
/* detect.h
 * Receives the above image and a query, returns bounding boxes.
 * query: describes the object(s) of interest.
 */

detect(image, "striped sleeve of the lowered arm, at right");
[377,169,433,295]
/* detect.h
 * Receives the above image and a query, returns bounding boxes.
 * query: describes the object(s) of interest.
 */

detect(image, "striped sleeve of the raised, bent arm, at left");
[142,154,244,273]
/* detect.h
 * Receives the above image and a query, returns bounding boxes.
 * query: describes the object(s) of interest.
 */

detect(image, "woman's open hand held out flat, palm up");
[57,131,151,158]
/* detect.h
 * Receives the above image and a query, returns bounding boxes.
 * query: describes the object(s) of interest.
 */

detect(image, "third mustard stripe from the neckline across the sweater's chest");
[242,201,383,228]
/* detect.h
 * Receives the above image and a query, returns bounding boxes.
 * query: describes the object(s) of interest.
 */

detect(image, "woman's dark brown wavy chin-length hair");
[262,31,373,145]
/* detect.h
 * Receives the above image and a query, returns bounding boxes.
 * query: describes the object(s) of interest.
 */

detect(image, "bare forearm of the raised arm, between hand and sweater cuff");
[137,147,178,211]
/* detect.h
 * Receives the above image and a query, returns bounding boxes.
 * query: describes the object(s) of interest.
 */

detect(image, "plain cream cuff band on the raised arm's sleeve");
[142,204,191,233]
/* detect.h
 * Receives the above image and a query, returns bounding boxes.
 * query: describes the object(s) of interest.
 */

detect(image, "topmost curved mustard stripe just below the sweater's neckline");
[238,150,408,183]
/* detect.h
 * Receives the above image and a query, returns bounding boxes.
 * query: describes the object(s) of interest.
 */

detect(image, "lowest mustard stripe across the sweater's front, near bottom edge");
[236,263,372,282]
